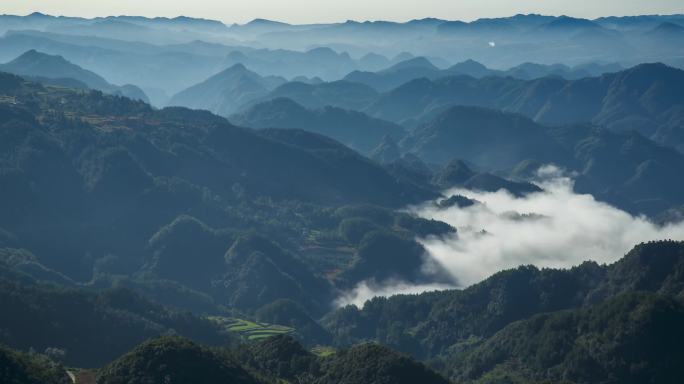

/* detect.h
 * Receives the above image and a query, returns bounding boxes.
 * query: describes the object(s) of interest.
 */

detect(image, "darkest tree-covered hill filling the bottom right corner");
[447,293,684,384]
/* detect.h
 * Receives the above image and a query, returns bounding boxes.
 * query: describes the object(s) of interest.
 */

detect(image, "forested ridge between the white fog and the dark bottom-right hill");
[323,241,684,380]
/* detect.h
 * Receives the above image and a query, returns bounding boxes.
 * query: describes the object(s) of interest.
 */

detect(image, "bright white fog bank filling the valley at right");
[337,166,684,306]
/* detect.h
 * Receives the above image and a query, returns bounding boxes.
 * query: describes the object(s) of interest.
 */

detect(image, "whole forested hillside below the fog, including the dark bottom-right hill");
[324,241,684,383]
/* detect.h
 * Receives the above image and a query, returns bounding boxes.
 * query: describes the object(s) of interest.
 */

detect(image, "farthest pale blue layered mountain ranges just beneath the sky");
[0,14,684,102]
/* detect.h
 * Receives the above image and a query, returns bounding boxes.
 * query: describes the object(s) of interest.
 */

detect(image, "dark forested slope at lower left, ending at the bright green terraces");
[0,263,234,367]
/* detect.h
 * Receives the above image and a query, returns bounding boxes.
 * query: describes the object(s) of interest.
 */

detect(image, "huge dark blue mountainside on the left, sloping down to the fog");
[0,74,441,306]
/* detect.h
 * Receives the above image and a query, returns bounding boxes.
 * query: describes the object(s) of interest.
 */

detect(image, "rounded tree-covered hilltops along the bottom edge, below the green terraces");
[97,336,448,384]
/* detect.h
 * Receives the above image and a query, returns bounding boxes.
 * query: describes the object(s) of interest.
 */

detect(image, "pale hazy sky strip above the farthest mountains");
[0,0,684,23]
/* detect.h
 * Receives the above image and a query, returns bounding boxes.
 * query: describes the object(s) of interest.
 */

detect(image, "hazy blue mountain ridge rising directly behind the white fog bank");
[224,80,684,216]
